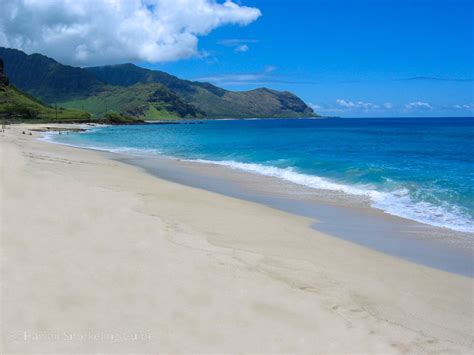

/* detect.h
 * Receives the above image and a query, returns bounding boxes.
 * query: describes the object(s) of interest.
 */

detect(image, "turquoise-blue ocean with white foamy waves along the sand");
[48,118,474,233]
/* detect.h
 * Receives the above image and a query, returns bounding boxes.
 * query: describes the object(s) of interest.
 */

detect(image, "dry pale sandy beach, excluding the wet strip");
[0,125,474,353]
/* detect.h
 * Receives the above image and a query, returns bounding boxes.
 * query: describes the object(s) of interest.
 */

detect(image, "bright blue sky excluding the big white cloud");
[142,0,474,117]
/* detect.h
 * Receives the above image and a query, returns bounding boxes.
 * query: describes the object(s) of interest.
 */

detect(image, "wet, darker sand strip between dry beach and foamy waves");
[39,127,474,277]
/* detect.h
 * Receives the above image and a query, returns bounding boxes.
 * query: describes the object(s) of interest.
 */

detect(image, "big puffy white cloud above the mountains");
[0,0,261,65]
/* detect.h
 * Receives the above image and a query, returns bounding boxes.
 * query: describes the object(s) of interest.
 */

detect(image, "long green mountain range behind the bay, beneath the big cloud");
[0,47,316,120]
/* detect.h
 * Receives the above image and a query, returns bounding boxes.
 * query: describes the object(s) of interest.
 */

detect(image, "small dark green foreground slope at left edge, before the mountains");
[0,58,90,122]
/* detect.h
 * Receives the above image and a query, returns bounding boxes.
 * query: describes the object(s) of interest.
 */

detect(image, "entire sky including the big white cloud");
[0,0,474,117]
